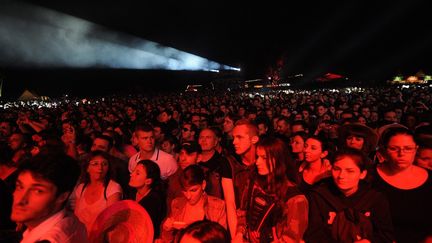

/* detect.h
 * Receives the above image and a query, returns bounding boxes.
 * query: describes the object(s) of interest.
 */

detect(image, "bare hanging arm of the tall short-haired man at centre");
[222,177,237,238]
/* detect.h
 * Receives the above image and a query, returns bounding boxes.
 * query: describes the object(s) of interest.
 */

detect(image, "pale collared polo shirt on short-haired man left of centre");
[129,149,178,180]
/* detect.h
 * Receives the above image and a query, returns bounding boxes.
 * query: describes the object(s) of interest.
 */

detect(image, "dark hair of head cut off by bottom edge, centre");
[175,220,229,243]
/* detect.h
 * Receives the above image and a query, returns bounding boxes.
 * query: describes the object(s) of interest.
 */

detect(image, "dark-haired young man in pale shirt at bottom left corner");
[11,153,88,243]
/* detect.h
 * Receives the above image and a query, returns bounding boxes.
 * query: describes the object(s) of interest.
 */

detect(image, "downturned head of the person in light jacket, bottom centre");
[180,165,206,205]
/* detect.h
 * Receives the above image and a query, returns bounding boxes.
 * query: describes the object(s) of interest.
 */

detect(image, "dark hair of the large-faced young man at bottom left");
[18,153,80,196]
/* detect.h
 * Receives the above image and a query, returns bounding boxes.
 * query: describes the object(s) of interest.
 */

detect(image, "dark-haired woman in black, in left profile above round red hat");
[129,160,166,239]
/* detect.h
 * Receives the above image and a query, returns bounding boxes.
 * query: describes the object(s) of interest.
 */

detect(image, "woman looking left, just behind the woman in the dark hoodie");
[297,136,333,191]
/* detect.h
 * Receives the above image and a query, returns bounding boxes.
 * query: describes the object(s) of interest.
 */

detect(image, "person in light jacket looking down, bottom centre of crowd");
[162,165,227,242]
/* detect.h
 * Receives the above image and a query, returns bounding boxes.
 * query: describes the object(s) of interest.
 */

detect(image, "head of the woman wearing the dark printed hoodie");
[332,149,367,196]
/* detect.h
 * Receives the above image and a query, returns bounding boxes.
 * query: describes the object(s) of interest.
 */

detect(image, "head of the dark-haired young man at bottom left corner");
[11,153,80,228]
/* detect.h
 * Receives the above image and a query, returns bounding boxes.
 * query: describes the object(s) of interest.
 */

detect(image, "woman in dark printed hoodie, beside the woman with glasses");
[305,149,394,242]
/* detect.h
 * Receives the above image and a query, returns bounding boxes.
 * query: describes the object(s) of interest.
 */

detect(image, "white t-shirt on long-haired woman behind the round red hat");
[74,180,123,234]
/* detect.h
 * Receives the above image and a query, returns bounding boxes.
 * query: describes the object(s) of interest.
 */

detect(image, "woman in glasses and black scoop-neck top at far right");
[373,127,432,242]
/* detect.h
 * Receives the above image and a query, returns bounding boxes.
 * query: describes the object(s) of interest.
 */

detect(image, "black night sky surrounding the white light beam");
[0,0,432,98]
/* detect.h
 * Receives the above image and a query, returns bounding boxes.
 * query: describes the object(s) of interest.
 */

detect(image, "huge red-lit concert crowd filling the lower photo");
[0,86,432,243]
